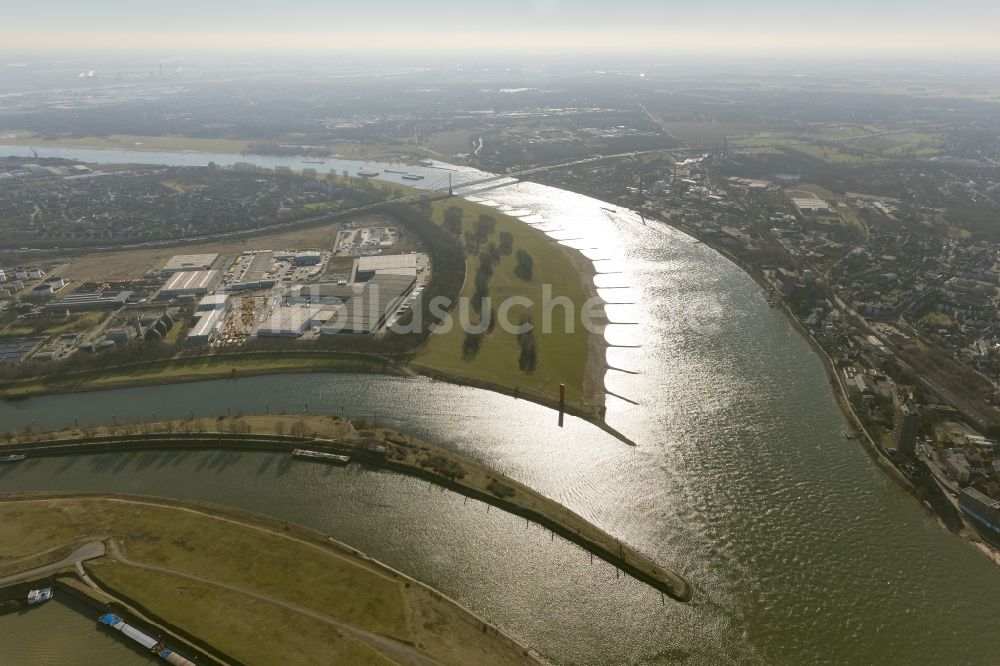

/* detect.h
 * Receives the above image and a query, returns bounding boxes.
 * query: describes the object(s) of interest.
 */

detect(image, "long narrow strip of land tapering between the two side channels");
[0,415,692,601]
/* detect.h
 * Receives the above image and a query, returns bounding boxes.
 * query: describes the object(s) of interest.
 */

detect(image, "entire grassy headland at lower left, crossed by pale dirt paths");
[0,493,542,666]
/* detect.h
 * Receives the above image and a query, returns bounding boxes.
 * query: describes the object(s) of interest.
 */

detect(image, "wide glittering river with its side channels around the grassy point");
[0,146,1000,664]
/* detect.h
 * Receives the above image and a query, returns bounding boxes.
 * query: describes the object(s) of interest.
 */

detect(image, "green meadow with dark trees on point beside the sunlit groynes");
[415,199,588,401]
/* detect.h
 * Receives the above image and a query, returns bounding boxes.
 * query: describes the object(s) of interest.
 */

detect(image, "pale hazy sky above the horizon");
[7,0,1000,57]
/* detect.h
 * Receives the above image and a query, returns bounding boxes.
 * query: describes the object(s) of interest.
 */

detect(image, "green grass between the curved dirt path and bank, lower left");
[0,499,411,640]
